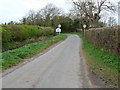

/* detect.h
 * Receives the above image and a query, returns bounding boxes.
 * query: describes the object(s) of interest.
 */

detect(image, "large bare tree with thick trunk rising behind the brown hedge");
[72,0,115,27]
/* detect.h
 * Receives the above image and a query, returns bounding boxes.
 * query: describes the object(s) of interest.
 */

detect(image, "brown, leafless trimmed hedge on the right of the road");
[85,26,120,56]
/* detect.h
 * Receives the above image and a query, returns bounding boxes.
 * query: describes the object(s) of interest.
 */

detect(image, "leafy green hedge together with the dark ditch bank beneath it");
[0,25,55,52]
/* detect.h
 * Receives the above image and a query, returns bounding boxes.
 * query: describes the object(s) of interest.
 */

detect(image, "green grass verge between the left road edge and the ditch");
[0,34,67,70]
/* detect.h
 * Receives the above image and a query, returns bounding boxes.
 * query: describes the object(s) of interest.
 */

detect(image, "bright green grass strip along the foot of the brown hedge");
[78,34,120,71]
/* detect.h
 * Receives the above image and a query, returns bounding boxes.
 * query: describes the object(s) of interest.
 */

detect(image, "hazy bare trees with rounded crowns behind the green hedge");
[21,4,63,26]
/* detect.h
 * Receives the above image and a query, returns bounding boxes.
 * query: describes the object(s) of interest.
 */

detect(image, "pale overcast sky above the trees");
[0,0,118,24]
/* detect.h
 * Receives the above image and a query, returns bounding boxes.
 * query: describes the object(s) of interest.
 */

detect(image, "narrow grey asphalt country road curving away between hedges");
[2,35,91,88]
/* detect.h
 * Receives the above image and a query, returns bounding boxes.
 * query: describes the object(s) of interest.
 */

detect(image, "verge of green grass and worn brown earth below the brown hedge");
[76,33,120,87]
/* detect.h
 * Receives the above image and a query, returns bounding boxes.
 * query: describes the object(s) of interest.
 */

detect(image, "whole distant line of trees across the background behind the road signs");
[5,4,105,32]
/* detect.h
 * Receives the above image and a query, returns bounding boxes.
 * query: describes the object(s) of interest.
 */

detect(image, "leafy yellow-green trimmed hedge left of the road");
[2,25,54,43]
